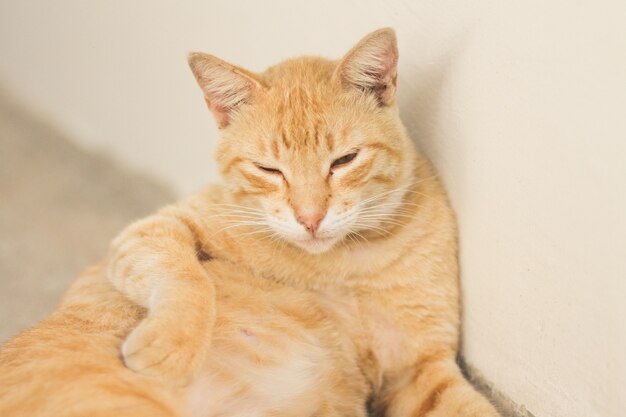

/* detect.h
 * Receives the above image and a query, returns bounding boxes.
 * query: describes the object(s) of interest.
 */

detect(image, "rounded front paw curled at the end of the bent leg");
[122,316,209,385]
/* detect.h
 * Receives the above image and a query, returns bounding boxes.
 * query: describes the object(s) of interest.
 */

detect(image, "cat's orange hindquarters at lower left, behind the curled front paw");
[0,274,182,417]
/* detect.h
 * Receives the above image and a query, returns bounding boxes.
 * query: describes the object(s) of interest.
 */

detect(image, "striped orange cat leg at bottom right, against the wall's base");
[385,351,500,417]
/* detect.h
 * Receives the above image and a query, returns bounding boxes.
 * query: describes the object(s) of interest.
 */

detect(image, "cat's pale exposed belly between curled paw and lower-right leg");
[187,276,367,417]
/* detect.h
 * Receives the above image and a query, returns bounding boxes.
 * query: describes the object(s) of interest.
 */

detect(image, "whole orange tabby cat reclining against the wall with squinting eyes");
[0,29,498,417]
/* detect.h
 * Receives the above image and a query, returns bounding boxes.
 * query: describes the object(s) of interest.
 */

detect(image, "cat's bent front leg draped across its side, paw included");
[107,195,215,384]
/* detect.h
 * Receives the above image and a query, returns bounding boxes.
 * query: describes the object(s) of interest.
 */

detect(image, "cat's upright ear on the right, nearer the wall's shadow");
[335,28,398,106]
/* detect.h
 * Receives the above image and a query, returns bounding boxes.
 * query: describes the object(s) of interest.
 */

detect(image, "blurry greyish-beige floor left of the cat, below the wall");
[0,94,172,343]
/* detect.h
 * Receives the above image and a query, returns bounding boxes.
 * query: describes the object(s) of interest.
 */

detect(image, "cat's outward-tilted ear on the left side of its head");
[188,52,263,129]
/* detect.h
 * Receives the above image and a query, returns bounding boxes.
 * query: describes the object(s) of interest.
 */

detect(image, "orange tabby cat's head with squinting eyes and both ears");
[189,29,415,253]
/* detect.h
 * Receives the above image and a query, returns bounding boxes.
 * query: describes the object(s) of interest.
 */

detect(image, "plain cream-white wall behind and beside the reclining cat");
[0,0,626,417]
